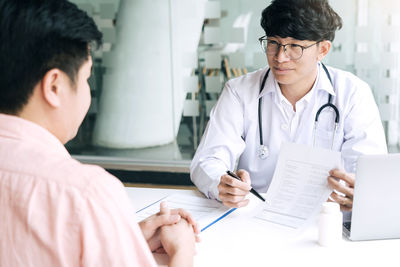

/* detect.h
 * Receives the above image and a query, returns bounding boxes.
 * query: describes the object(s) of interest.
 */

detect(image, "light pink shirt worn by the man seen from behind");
[0,114,156,267]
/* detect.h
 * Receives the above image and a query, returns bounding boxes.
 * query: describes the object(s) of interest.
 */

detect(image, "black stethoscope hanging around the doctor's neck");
[258,63,340,159]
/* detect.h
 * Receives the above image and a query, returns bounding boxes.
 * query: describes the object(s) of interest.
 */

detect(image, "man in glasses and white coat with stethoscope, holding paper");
[191,0,387,211]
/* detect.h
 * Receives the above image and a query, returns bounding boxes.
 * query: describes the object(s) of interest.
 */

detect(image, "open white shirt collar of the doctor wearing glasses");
[258,62,336,102]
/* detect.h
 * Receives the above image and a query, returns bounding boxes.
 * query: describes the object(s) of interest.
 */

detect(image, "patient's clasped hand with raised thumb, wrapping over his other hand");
[139,202,200,252]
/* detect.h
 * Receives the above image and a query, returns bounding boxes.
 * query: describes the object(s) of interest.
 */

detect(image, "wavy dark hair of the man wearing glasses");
[261,0,342,42]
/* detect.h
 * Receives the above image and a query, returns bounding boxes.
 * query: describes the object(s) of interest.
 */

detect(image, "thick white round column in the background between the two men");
[93,0,204,148]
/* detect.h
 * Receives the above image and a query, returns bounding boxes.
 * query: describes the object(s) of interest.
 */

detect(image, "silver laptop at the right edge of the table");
[343,154,400,241]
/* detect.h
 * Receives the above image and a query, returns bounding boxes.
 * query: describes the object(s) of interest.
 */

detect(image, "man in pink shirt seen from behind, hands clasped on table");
[0,0,198,267]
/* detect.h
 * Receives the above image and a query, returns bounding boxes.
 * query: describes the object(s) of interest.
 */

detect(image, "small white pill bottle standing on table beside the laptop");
[318,202,343,247]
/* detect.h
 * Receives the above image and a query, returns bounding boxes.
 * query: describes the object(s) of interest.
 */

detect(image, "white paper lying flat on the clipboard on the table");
[136,194,233,231]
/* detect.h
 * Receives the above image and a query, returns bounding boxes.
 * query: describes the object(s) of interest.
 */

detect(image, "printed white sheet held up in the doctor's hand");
[255,143,341,229]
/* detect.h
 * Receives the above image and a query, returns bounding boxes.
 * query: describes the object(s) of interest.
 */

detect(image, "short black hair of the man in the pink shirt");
[0,0,102,115]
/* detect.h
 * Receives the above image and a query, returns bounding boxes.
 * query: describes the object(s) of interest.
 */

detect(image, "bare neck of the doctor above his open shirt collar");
[278,67,318,111]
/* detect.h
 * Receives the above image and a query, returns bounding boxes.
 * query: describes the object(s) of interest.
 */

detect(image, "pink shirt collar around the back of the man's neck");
[0,113,71,158]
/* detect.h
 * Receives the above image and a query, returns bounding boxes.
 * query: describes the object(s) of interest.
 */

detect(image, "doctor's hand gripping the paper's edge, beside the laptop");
[328,169,355,211]
